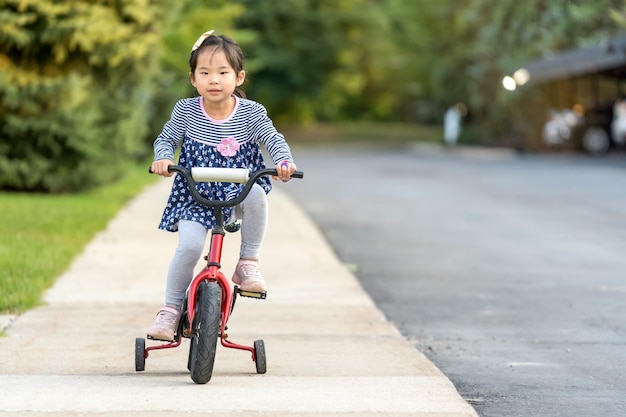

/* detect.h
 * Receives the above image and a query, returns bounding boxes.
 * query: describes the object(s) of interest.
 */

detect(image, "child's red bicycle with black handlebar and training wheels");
[135,165,303,384]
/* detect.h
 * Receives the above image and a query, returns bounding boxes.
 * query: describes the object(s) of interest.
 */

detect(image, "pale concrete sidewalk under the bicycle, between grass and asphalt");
[0,179,477,417]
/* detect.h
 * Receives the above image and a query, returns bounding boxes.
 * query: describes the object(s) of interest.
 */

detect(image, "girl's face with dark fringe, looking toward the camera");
[189,48,246,105]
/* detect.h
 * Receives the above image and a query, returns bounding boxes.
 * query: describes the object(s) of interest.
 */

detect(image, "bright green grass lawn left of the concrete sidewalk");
[0,164,156,314]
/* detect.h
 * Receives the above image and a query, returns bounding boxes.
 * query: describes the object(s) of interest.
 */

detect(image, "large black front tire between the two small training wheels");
[189,281,222,384]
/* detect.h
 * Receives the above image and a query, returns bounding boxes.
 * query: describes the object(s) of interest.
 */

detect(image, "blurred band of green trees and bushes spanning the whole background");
[0,0,626,192]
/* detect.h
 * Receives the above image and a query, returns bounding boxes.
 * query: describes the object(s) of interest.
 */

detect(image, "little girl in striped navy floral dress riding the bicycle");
[148,31,296,341]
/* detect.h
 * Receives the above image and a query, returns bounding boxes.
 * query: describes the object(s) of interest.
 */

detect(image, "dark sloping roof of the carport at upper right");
[523,35,626,85]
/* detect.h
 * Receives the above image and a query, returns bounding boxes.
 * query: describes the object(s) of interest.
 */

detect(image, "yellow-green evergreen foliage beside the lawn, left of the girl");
[0,0,160,192]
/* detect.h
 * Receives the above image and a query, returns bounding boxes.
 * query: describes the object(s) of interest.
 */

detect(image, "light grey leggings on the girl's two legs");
[165,184,268,307]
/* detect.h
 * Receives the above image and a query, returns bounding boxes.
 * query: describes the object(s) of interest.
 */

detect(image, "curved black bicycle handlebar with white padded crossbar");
[148,165,304,207]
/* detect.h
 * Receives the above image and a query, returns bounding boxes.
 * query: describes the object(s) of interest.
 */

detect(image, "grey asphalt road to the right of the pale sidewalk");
[288,143,626,417]
